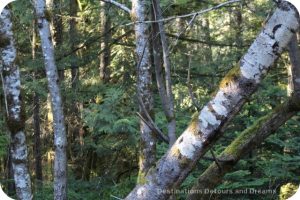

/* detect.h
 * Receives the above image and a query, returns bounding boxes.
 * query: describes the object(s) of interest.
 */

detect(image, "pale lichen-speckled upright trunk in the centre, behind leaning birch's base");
[131,0,156,182]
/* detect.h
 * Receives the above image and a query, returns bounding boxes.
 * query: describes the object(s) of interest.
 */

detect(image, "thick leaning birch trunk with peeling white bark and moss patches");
[126,2,299,199]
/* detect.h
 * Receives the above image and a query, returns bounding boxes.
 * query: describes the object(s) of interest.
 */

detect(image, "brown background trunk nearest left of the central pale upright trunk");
[99,1,111,83]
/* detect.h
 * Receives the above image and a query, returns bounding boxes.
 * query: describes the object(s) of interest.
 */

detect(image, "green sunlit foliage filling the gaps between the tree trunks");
[0,0,300,200]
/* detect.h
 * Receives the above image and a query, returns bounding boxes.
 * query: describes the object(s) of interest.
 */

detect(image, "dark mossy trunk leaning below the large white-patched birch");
[187,96,299,200]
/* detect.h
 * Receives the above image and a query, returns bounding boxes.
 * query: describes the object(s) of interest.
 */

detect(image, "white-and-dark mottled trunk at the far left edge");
[0,9,32,200]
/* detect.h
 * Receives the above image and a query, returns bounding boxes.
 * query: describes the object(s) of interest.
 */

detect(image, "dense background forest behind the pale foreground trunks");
[0,0,300,199]
